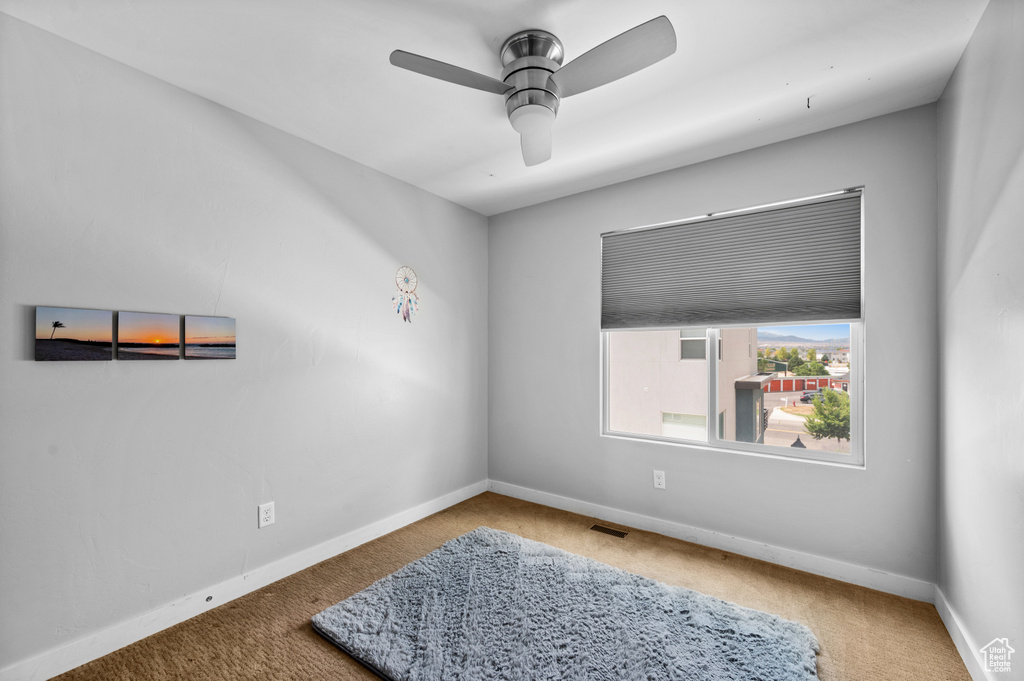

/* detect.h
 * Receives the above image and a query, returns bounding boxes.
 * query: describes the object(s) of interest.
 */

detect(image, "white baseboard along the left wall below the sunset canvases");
[0,480,487,681]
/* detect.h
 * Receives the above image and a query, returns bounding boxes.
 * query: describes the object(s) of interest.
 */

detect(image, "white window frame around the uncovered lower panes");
[600,320,866,469]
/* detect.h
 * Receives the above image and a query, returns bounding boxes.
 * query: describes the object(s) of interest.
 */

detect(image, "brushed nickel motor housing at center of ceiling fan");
[499,29,564,119]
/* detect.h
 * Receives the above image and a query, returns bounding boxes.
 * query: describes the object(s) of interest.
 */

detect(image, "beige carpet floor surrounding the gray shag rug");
[56,493,971,681]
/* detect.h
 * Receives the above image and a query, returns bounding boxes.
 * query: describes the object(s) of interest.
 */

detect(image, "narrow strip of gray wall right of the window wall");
[938,0,1024,659]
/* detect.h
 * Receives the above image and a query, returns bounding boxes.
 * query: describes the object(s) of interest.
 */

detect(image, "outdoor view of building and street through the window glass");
[605,324,851,454]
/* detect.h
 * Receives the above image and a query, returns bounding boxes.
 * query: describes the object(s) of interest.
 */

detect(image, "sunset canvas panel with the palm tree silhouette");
[36,306,114,361]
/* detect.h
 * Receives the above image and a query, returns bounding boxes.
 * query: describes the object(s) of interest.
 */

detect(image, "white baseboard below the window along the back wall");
[489,480,935,603]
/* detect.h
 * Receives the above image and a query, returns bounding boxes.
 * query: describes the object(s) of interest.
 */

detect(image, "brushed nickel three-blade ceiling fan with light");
[391,16,676,166]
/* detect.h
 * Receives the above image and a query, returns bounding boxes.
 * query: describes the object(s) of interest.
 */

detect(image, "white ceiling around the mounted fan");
[0,0,987,215]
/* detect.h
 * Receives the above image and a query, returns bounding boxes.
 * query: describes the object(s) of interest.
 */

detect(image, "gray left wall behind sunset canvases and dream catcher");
[0,14,487,669]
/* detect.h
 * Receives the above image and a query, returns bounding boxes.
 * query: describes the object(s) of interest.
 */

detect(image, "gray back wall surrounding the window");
[488,107,938,582]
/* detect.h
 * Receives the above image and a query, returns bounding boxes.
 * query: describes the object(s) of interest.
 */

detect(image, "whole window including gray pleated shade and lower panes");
[602,190,863,465]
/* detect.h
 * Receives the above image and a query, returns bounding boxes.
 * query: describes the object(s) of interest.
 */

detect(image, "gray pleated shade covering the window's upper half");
[601,189,861,330]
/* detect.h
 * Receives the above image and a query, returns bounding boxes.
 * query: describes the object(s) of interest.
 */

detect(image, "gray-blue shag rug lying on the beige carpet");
[312,527,818,681]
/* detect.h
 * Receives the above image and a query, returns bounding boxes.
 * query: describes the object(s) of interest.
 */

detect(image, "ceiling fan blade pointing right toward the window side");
[551,16,676,97]
